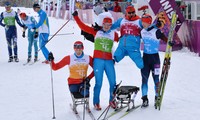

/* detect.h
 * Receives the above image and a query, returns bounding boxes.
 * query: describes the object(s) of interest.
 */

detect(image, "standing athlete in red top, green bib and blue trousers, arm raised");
[73,11,118,110]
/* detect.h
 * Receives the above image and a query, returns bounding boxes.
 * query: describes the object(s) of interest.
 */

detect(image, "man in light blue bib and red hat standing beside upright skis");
[141,14,167,107]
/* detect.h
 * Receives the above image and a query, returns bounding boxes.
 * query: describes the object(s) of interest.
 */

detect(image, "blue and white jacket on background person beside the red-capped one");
[34,9,50,34]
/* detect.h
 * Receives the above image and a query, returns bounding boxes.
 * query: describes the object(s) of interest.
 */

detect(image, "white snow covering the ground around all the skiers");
[0,8,200,120]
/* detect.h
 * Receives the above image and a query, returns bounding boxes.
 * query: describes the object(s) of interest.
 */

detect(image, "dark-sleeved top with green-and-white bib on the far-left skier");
[0,9,23,29]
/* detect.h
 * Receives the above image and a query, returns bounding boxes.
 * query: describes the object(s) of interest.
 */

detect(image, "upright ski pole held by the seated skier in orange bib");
[50,61,56,119]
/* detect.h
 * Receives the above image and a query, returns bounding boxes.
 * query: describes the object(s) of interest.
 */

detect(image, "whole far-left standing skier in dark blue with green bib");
[0,2,24,62]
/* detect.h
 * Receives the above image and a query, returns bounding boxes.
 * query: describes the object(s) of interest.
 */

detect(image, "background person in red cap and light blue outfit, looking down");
[19,12,38,62]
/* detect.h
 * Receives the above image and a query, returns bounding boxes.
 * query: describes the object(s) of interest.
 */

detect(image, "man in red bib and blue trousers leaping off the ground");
[111,6,144,69]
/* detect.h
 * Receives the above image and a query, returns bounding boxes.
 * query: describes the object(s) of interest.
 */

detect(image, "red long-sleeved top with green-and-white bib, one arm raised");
[74,16,118,60]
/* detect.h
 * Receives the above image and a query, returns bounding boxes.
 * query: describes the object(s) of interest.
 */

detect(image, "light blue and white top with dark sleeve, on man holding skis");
[141,26,167,54]
